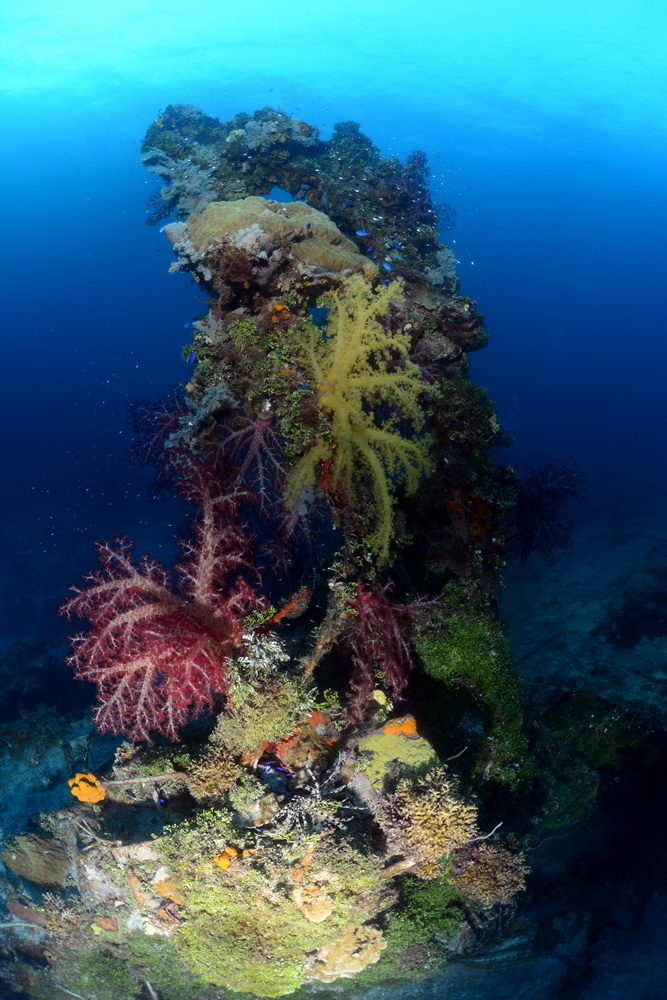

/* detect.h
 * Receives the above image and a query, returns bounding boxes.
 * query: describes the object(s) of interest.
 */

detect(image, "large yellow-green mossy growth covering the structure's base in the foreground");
[156,814,388,997]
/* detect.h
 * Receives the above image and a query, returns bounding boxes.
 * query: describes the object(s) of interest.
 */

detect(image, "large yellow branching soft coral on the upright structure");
[286,275,429,564]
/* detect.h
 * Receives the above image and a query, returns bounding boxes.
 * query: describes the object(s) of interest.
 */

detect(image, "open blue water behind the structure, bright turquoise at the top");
[0,0,667,995]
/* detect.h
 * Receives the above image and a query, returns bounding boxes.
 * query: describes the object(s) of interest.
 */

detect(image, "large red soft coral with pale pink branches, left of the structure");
[61,459,257,742]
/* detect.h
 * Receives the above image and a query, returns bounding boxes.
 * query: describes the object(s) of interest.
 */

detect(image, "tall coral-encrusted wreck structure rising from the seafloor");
[5,105,530,1000]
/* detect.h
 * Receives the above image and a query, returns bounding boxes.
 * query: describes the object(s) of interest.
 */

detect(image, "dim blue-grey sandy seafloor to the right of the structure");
[502,502,667,721]
